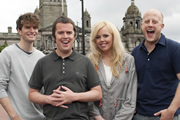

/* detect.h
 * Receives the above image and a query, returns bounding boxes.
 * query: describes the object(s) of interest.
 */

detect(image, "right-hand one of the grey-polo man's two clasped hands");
[53,86,74,106]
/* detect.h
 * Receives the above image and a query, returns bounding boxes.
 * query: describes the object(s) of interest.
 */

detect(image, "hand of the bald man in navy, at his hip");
[154,109,174,120]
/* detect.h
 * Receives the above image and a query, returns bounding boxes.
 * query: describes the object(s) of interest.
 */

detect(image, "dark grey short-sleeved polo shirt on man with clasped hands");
[29,50,100,120]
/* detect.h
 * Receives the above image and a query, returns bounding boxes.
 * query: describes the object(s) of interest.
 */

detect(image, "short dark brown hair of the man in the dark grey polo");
[52,16,76,39]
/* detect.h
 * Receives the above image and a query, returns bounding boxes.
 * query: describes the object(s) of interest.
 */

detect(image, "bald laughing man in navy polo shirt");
[132,9,180,120]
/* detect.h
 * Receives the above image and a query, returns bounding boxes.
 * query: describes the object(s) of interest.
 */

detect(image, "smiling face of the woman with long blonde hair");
[95,26,113,53]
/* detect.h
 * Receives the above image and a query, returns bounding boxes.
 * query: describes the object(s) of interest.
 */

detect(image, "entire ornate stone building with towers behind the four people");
[0,0,143,54]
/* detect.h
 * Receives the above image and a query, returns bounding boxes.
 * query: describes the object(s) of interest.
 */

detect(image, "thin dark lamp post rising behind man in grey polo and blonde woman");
[80,0,86,55]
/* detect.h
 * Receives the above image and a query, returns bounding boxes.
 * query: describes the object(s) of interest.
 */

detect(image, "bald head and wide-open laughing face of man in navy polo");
[141,9,164,43]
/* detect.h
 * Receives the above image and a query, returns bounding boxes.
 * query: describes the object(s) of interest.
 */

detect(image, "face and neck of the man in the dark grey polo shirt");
[55,23,75,56]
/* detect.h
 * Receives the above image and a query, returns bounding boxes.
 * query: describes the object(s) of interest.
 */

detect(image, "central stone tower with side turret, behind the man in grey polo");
[34,0,91,54]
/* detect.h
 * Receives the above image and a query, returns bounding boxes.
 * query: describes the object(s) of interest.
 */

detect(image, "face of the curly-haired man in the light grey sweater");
[18,24,38,43]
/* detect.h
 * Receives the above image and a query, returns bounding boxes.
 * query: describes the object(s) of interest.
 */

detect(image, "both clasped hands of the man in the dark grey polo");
[49,86,74,108]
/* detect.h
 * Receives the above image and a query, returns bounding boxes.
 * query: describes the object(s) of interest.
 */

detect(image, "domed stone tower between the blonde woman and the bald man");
[121,0,144,52]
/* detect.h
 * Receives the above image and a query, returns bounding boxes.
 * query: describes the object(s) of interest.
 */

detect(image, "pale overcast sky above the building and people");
[0,0,180,41]
